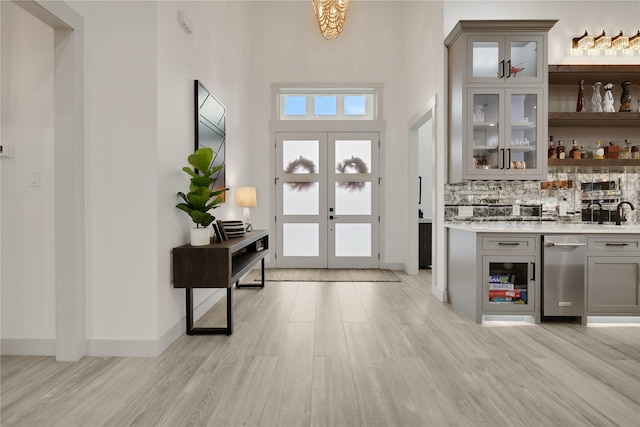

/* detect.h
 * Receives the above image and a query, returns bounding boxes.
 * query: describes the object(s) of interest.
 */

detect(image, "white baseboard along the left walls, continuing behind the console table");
[0,289,226,357]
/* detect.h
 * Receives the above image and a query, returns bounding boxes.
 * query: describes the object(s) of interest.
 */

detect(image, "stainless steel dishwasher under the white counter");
[542,234,587,317]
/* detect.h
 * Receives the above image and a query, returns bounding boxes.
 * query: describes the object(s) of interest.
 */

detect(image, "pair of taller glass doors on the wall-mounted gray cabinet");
[464,88,546,179]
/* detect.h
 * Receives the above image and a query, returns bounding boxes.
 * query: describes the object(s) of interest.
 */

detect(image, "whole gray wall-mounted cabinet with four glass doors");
[445,20,556,182]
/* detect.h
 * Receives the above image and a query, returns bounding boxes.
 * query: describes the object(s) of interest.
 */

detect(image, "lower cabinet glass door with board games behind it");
[482,255,536,313]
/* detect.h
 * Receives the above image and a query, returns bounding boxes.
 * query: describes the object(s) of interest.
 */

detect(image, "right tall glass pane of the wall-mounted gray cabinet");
[510,94,538,169]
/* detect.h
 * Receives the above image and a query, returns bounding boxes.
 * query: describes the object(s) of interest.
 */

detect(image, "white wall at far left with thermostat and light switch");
[0,2,55,353]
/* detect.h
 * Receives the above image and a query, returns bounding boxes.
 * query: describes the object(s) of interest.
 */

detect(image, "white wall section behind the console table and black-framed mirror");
[156,1,253,341]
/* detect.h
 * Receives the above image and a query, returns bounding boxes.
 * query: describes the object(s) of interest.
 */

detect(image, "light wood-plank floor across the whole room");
[0,271,640,427]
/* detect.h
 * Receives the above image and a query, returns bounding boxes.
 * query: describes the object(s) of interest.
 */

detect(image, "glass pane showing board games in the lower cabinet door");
[486,262,529,304]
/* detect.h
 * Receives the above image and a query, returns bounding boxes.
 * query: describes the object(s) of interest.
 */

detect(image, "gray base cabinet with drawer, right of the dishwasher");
[586,235,640,315]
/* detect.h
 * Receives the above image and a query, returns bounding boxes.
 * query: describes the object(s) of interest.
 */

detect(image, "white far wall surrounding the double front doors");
[251,2,422,266]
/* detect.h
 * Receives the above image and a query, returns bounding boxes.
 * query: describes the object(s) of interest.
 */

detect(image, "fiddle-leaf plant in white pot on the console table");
[176,147,228,246]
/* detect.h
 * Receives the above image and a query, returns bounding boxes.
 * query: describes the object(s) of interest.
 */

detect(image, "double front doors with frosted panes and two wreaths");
[275,132,380,268]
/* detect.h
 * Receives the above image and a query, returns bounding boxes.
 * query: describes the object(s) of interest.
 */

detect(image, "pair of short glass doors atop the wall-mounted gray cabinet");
[467,35,545,85]
